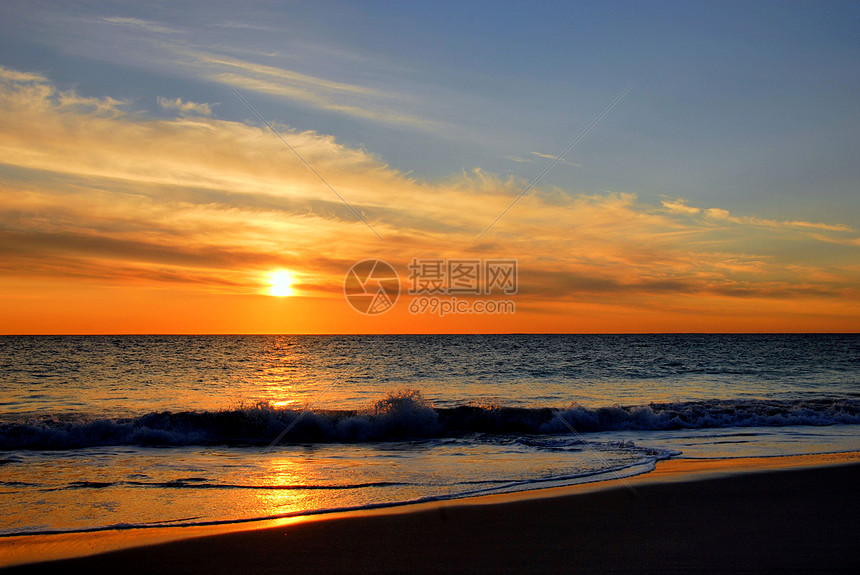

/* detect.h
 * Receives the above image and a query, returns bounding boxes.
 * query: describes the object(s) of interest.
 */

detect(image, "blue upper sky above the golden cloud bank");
[0,2,860,220]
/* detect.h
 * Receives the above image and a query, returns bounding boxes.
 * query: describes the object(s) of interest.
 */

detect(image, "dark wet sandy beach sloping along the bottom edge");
[0,453,860,573]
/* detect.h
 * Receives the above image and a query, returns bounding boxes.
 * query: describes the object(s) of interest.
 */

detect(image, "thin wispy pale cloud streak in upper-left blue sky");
[5,10,498,153]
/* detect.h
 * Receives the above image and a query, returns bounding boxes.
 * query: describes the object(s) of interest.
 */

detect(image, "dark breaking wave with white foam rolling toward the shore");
[0,389,860,451]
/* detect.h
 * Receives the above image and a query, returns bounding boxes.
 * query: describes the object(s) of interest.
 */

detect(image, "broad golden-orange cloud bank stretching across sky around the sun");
[0,68,860,305]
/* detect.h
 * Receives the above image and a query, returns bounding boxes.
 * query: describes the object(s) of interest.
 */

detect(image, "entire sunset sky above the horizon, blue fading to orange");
[0,0,860,334]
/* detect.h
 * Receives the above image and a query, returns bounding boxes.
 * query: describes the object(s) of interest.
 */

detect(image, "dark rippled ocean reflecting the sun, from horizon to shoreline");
[0,335,860,536]
